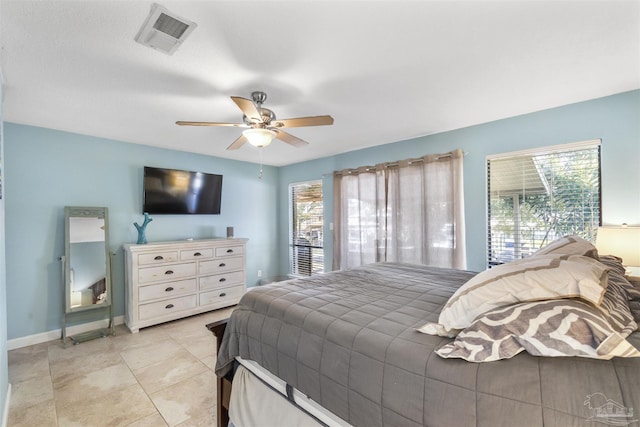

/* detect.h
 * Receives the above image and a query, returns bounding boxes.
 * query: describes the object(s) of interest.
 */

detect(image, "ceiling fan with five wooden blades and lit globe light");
[176,91,333,150]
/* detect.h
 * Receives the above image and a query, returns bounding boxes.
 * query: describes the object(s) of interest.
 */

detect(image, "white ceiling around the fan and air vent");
[0,0,640,165]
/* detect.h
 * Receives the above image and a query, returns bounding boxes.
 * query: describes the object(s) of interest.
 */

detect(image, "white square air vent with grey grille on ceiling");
[135,4,197,55]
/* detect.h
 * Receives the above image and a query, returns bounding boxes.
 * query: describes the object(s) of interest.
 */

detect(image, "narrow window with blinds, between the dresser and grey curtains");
[289,180,324,276]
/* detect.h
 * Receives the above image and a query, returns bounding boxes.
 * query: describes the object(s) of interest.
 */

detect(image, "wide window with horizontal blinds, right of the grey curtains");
[487,140,601,267]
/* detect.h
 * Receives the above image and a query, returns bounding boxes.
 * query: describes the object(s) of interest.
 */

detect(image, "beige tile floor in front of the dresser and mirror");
[8,308,232,427]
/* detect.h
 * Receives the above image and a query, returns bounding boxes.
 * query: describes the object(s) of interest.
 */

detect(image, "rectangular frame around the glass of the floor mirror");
[64,206,112,313]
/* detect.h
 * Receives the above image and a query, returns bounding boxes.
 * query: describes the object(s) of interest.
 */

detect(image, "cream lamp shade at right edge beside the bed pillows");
[596,227,640,267]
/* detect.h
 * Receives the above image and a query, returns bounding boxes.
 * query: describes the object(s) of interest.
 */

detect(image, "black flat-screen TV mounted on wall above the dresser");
[142,166,222,215]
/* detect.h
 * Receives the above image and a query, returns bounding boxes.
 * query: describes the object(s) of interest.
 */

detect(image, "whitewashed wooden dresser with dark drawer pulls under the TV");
[124,239,247,333]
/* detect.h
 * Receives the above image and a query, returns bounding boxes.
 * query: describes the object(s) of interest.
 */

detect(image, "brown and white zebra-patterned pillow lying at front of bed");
[436,283,640,362]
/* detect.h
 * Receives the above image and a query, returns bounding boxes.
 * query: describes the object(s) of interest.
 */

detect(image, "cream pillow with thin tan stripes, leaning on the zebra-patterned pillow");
[419,254,608,336]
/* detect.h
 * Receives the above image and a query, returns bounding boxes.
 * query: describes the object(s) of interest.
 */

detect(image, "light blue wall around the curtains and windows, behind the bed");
[278,90,640,273]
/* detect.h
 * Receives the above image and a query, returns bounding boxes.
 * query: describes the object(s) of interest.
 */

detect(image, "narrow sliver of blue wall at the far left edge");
[0,71,9,423]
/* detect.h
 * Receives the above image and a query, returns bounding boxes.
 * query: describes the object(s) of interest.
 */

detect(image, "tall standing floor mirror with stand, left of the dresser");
[62,206,115,346]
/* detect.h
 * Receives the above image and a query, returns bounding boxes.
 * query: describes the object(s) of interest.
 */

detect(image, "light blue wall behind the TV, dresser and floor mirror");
[0,123,279,339]
